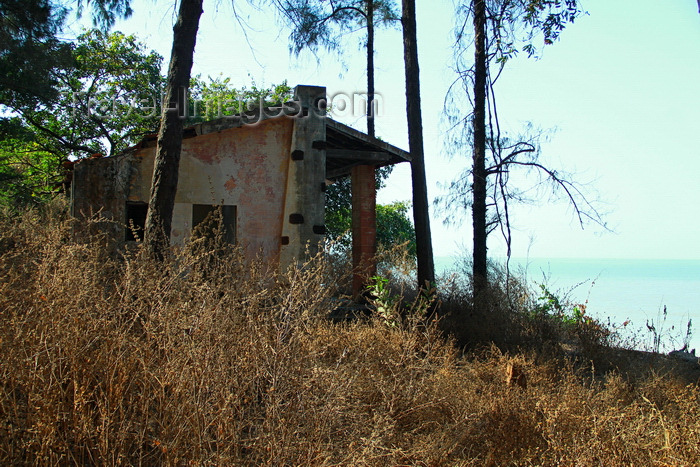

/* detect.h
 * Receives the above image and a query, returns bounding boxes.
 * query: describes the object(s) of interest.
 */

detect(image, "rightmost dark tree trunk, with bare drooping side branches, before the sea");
[472,0,488,302]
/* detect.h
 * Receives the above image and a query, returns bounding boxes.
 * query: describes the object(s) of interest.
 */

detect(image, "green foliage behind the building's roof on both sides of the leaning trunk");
[13,29,292,158]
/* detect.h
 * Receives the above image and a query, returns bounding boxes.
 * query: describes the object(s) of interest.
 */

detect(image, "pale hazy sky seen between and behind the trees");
[65,0,700,259]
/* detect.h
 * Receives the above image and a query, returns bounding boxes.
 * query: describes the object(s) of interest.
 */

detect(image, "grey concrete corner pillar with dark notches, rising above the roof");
[280,86,326,269]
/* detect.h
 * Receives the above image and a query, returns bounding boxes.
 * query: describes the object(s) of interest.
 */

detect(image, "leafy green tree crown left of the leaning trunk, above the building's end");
[13,30,163,158]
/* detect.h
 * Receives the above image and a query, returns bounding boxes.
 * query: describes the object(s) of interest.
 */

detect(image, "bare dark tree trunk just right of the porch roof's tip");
[401,0,435,288]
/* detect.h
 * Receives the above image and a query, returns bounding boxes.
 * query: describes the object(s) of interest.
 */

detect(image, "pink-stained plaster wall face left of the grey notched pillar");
[128,117,294,260]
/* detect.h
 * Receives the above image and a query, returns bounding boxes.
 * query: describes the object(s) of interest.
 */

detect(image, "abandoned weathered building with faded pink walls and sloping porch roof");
[71,86,410,288]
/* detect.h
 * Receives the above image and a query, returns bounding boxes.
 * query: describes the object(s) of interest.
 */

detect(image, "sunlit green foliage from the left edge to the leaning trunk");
[0,30,162,209]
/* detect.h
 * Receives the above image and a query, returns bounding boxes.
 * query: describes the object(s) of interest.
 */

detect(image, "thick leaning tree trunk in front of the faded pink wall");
[144,0,203,259]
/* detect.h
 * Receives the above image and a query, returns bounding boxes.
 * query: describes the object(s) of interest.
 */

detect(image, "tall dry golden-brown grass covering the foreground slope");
[0,203,700,466]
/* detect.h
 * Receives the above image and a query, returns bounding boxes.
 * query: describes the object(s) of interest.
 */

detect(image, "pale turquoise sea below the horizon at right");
[435,257,700,356]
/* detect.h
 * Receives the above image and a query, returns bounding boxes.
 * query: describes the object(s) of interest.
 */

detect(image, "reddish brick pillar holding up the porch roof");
[350,165,377,297]
